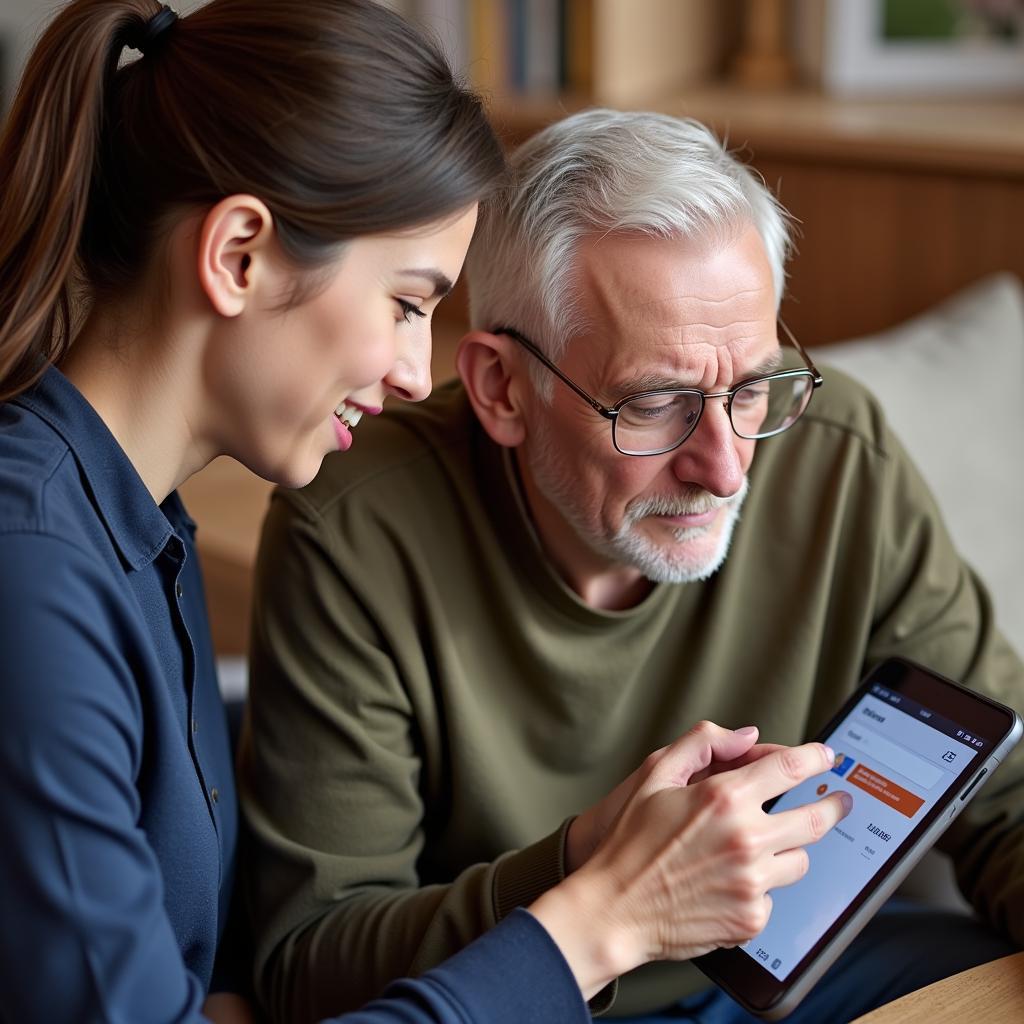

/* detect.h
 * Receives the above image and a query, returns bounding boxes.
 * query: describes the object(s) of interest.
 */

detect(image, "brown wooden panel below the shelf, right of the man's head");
[755,159,1024,345]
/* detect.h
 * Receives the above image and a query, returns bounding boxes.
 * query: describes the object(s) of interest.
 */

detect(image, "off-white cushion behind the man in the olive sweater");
[813,273,1024,652]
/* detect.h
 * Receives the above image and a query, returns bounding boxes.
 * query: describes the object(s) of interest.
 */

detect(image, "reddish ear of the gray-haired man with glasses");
[455,331,529,447]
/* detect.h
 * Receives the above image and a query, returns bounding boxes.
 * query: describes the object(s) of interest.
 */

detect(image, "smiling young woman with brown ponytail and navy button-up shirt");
[0,0,843,1024]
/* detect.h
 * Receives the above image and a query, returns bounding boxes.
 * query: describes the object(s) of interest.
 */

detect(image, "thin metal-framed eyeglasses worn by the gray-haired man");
[492,321,822,456]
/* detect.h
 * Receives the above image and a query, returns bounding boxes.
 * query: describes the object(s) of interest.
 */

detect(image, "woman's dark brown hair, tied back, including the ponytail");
[0,0,504,400]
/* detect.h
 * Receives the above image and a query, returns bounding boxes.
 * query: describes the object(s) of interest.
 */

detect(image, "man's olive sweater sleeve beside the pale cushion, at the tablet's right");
[867,421,1024,945]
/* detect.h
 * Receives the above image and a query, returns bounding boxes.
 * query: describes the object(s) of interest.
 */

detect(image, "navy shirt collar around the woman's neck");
[15,367,196,570]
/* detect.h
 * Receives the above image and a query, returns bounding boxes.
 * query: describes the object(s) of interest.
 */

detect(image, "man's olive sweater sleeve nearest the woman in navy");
[240,496,566,1022]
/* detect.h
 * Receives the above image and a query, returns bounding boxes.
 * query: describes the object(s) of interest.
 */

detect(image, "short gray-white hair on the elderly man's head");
[466,110,791,396]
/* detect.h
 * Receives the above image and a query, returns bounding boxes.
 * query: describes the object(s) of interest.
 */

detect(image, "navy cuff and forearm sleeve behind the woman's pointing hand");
[323,910,591,1024]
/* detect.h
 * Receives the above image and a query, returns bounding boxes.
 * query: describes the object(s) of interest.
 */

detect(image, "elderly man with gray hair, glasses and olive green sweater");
[237,111,1024,1022]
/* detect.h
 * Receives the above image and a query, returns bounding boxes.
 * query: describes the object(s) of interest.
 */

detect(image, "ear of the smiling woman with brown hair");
[199,196,273,316]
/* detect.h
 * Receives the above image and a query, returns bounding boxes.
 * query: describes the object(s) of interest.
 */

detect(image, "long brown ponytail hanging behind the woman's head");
[0,0,161,400]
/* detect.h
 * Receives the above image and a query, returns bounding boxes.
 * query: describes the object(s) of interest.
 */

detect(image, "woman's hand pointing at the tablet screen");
[529,723,849,995]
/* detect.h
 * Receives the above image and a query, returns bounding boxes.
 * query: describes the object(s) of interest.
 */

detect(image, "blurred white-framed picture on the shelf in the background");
[798,0,1024,95]
